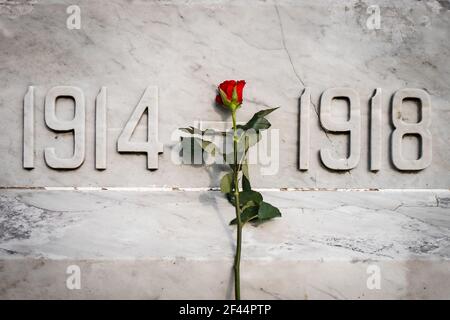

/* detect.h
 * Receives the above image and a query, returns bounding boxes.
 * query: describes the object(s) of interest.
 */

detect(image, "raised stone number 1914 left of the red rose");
[23,86,163,170]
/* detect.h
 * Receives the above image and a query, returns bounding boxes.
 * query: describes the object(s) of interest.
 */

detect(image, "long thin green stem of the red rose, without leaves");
[232,111,242,300]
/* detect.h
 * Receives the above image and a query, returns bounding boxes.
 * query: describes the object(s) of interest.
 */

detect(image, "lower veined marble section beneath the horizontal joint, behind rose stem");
[0,190,450,299]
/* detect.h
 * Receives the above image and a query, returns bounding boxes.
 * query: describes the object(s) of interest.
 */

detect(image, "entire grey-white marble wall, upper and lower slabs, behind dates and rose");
[0,0,450,299]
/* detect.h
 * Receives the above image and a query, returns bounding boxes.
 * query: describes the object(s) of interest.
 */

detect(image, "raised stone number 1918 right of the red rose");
[299,88,432,171]
